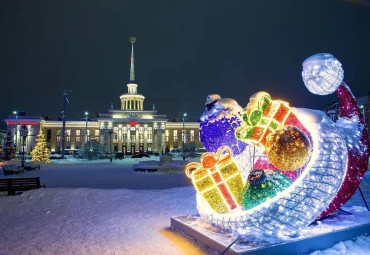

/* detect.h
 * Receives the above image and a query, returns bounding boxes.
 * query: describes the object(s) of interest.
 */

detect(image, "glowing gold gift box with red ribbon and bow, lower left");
[185,146,244,213]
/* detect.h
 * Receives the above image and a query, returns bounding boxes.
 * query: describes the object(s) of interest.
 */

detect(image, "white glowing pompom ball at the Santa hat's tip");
[302,53,343,95]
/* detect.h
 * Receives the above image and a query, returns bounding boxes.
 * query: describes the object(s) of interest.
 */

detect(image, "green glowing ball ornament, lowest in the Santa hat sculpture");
[243,169,292,209]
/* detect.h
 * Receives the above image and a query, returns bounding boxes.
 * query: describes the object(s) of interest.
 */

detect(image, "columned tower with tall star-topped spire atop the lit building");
[120,37,145,111]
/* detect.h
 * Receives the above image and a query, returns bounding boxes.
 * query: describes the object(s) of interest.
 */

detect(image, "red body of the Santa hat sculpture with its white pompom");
[302,53,369,218]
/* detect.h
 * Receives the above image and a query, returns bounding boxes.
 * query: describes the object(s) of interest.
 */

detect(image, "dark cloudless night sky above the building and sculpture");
[0,0,370,128]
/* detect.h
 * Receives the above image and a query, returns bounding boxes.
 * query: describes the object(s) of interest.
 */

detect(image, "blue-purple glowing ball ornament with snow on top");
[199,94,247,156]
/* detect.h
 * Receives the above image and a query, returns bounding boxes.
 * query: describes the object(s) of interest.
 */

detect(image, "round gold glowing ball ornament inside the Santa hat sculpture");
[265,126,312,171]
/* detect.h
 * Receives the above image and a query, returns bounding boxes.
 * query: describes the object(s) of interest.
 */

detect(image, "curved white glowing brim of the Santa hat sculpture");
[197,109,347,235]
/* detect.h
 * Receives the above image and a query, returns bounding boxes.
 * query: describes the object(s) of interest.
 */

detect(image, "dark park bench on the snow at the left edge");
[0,177,45,196]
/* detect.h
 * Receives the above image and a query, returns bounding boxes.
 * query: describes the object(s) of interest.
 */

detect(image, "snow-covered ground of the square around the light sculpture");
[0,159,370,255]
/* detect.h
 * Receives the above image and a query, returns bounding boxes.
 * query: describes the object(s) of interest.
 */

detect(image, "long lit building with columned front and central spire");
[5,38,202,154]
